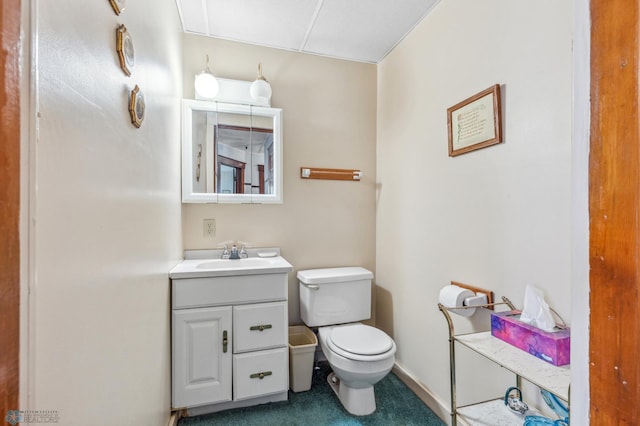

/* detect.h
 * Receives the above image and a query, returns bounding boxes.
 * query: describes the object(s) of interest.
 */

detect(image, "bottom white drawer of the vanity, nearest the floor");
[233,348,289,400]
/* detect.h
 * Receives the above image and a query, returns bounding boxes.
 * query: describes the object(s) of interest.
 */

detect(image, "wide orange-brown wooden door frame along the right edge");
[589,0,640,425]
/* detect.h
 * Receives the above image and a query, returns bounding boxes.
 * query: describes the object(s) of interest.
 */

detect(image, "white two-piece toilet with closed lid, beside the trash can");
[298,267,396,416]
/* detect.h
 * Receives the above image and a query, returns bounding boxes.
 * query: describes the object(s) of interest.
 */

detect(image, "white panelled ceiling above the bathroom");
[176,0,440,64]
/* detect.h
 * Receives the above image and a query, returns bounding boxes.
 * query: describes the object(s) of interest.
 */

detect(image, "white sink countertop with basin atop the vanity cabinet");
[169,250,293,278]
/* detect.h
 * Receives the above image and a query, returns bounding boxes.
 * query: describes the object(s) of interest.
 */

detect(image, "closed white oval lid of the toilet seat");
[331,324,393,355]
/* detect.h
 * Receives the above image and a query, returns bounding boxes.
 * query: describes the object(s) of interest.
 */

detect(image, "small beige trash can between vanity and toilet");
[289,325,318,392]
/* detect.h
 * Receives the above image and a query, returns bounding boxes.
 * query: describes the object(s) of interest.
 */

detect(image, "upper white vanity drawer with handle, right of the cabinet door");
[233,302,288,353]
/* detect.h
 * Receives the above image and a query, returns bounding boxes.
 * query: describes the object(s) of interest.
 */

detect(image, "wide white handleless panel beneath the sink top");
[171,273,288,309]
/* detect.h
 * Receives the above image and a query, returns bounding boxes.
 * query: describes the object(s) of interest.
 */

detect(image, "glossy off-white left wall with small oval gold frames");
[30,0,182,425]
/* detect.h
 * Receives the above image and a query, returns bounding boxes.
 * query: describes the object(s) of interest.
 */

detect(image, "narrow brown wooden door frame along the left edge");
[0,1,21,419]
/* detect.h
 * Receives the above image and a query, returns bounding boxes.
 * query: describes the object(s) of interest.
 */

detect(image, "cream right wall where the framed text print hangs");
[376,0,573,420]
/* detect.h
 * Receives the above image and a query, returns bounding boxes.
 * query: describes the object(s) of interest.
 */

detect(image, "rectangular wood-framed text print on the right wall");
[447,84,502,157]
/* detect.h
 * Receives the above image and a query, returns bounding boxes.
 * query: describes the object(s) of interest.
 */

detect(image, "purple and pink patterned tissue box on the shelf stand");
[491,311,571,365]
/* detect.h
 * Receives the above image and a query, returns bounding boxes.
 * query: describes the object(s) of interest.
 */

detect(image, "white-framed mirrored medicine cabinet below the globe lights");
[182,99,282,203]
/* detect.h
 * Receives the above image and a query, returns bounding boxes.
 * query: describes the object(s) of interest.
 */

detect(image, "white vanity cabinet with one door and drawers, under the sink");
[170,253,292,415]
